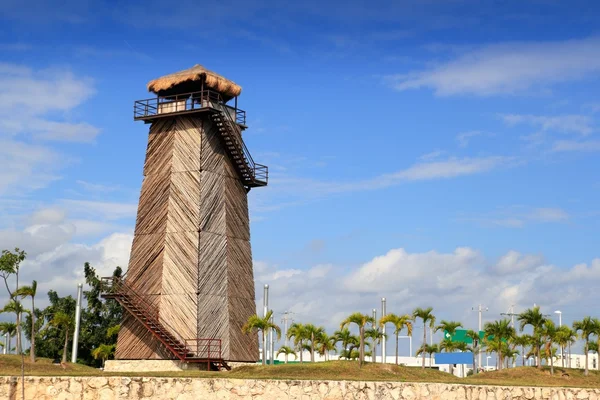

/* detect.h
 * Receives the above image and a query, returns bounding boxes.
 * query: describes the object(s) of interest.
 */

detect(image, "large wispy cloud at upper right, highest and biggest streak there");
[388,37,600,96]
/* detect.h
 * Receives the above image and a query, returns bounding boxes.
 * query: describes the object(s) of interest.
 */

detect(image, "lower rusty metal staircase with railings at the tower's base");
[101,277,231,370]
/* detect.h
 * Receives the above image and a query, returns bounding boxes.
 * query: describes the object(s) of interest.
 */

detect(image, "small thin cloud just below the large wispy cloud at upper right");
[502,114,595,136]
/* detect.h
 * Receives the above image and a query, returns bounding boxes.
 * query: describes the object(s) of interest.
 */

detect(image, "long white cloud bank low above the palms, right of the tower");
[255,247,600,348]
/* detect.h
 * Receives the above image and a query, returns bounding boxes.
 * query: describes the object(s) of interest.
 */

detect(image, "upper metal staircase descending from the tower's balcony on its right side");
[210,104,268,188]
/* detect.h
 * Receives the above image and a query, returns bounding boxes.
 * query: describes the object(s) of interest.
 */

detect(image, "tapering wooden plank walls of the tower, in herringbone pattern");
[116,116,258,362]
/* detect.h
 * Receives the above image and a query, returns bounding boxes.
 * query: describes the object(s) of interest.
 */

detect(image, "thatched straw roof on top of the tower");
[147,64,242,101]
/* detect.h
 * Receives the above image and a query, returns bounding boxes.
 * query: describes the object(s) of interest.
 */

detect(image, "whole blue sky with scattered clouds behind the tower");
[0,0,600,350]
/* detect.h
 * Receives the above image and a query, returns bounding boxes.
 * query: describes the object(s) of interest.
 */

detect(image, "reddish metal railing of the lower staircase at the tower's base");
[101,276,222,363]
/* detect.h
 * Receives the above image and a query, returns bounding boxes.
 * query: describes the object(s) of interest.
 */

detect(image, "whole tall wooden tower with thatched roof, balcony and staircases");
[105,65,268,362]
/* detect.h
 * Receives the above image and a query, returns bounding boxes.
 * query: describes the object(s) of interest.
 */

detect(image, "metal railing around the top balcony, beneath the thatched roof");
[133,89,246,126]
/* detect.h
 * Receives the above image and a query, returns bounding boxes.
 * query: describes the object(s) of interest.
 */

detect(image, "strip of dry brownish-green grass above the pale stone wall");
[0,355,600,387]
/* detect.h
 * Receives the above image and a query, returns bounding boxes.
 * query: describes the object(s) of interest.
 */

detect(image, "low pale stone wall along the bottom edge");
[0,377,600,400]
